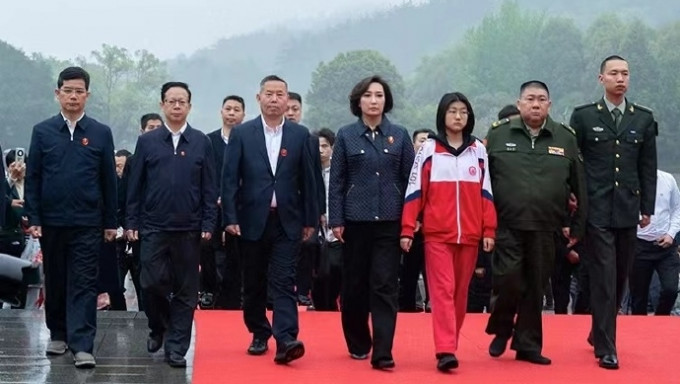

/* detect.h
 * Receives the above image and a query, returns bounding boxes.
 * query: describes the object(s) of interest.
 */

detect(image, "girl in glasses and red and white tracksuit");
[401,92,496,371]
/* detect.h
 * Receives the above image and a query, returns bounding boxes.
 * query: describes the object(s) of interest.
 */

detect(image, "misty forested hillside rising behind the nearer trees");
[169,0,680,106]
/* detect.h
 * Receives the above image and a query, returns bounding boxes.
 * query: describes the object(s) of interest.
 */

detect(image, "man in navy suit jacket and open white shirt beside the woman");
[222,75,319,364]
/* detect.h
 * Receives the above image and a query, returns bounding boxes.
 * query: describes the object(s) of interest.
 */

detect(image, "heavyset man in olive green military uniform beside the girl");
[486,80,586,365]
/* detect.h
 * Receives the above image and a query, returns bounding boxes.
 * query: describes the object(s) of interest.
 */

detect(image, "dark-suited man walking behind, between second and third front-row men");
[205,95,246,309]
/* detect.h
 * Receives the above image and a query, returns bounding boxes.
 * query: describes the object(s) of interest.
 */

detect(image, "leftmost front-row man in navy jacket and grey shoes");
[25,67,117,368]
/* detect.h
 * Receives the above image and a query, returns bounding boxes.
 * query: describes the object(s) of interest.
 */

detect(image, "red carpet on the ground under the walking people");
[193,311,680,384]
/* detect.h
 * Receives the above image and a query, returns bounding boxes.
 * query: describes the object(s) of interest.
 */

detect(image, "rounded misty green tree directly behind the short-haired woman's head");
[305,50,404,129]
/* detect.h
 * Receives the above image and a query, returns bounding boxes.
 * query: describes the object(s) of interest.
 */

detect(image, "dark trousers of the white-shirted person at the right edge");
[629,239,680,316]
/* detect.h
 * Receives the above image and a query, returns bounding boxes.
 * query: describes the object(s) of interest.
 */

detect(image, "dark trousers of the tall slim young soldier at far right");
[582,224,637,356]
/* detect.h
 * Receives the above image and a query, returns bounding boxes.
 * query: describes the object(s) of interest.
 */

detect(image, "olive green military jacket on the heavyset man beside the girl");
[486,117,586,238]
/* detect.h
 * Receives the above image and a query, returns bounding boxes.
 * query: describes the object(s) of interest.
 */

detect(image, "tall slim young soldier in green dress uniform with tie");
[571,56,657,369]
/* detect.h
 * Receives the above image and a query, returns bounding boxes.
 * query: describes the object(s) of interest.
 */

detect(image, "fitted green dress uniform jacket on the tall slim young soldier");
[570,99,657,228]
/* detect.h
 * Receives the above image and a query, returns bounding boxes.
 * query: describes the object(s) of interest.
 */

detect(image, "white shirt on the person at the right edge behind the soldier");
[638,170,680,241]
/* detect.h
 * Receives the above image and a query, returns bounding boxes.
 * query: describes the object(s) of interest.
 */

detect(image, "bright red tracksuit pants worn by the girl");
[425,243,478,353]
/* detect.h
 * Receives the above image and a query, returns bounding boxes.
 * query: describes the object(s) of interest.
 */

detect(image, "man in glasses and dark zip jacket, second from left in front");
[126,82,217,367]
